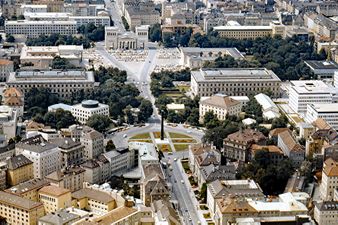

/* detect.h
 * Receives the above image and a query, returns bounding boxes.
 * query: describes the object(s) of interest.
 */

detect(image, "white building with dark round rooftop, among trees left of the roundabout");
[71,100,109,124]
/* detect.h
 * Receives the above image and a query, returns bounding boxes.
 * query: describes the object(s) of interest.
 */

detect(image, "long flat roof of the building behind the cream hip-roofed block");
[191,68,280,82]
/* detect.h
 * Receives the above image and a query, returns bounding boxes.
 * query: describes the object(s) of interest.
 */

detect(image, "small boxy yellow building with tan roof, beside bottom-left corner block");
[39,185,71,214]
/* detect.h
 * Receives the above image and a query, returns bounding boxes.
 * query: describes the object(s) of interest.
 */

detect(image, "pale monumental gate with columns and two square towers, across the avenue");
[105,25,148,50]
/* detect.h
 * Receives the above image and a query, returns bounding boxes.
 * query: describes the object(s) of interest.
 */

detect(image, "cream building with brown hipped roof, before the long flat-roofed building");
[199,94,242,122]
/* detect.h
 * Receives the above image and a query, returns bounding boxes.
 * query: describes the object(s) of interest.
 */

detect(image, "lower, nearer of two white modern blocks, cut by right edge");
[305,103,338,130]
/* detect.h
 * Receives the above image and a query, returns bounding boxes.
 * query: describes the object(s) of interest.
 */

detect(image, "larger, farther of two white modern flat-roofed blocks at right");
[289,80,334,115]
